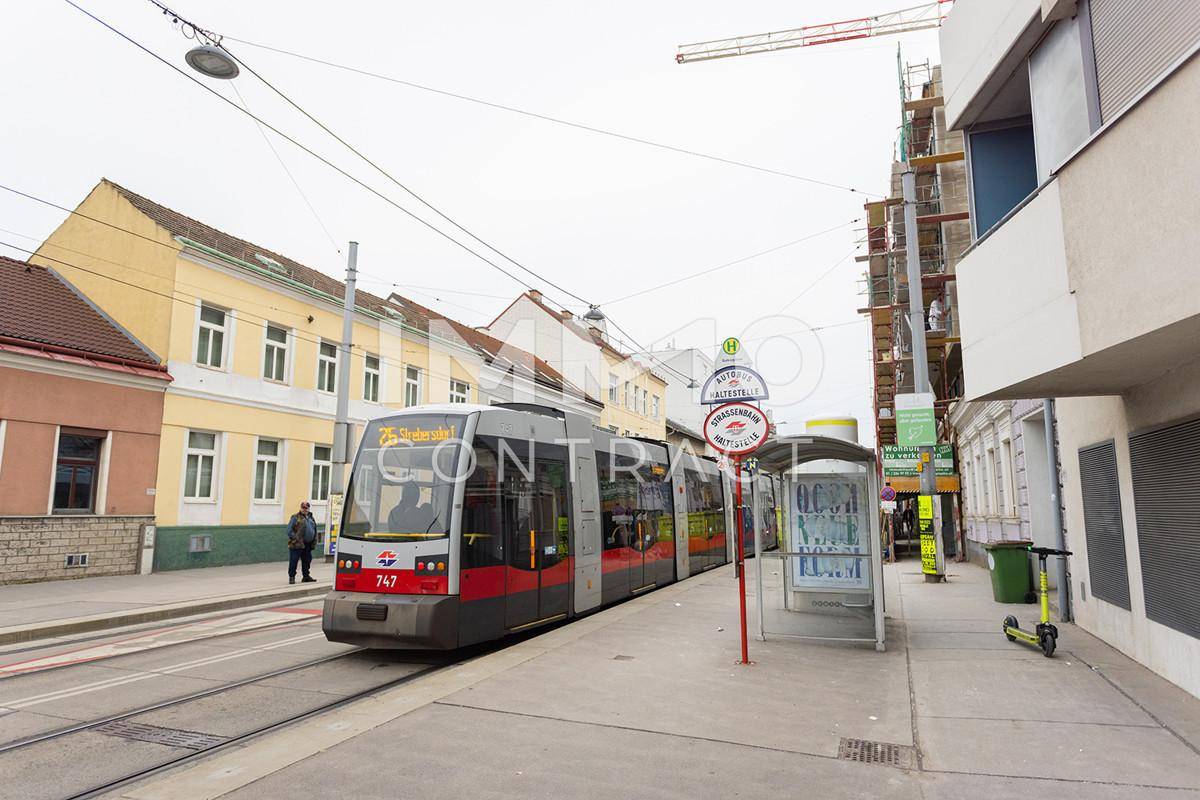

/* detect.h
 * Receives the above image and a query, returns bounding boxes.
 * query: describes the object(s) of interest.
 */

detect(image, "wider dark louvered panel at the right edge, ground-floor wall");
[1129,420,1200,638]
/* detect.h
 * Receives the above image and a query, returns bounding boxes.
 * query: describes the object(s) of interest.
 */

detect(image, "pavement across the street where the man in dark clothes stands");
[0,555,332,645]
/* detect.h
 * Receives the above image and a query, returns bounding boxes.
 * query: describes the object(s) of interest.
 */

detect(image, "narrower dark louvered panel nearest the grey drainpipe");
[1079,440,1129,609]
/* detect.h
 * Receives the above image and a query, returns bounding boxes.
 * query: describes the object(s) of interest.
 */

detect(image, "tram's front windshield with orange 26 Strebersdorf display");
[342,414,469,542]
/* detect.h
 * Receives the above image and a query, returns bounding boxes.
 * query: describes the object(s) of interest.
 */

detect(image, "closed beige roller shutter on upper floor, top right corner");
[1090,0,1200,122]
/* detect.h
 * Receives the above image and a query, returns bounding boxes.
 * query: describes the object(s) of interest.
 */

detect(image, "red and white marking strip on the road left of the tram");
[0,608,320,676]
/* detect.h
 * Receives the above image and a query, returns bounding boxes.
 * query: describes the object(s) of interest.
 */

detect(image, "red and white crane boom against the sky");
[676,0,954,64]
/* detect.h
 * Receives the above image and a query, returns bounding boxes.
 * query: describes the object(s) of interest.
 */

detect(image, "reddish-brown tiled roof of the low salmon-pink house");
[0,255,158,367]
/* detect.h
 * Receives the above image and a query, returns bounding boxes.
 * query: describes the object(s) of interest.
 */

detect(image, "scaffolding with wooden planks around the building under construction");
[858,54,971,554]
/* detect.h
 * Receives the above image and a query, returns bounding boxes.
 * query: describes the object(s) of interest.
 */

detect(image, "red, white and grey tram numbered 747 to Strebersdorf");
[322,403,736,649]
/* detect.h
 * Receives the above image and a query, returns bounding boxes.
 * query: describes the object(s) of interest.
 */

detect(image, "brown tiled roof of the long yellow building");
[103,178,408,330]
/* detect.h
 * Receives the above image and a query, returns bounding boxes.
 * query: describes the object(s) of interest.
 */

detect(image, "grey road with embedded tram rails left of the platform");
[0,600,445,800]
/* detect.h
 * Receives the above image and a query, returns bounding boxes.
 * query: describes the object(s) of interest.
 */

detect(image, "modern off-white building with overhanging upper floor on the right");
[941,0,1200,696]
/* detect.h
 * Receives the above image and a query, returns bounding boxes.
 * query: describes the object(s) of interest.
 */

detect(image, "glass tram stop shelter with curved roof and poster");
[751,435,886,651]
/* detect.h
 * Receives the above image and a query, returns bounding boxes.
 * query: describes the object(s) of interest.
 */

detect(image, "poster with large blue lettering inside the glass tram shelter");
[788,474,871,591]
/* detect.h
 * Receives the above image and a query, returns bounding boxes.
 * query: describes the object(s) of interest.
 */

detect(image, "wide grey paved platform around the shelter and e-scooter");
[105,561,1200,800]
